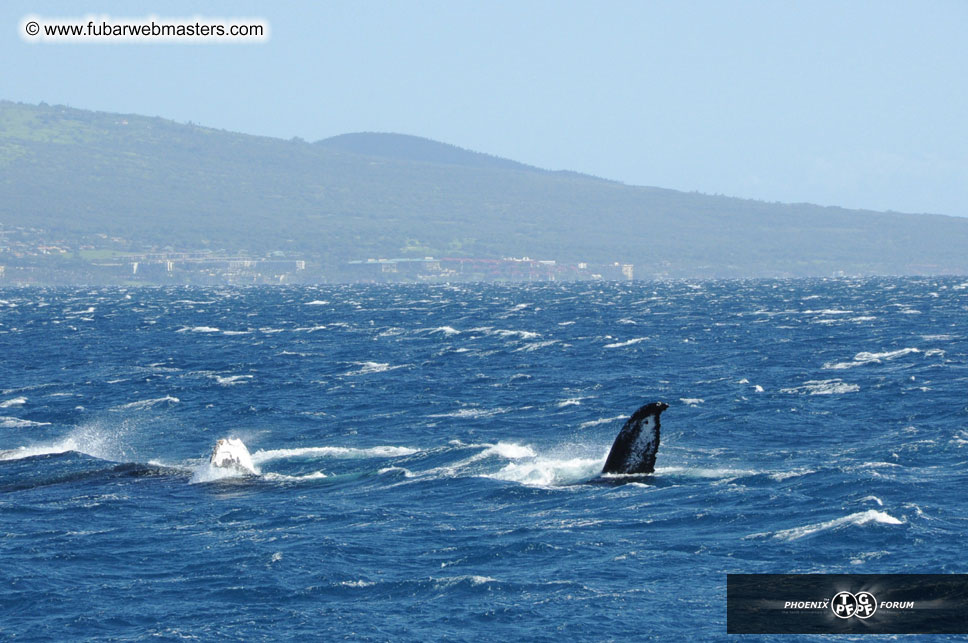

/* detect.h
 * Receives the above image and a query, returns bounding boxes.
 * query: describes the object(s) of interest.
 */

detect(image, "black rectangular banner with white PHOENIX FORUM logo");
[726,574,968,634]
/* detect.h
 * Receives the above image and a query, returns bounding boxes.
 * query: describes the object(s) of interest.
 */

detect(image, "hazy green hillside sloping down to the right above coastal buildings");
[0,102,968,278]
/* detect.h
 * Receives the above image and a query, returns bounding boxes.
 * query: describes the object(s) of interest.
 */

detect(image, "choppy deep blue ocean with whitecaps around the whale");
[0,278,968,641]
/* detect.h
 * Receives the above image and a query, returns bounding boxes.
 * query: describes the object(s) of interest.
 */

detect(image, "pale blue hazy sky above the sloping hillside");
[0,0,968,216]
